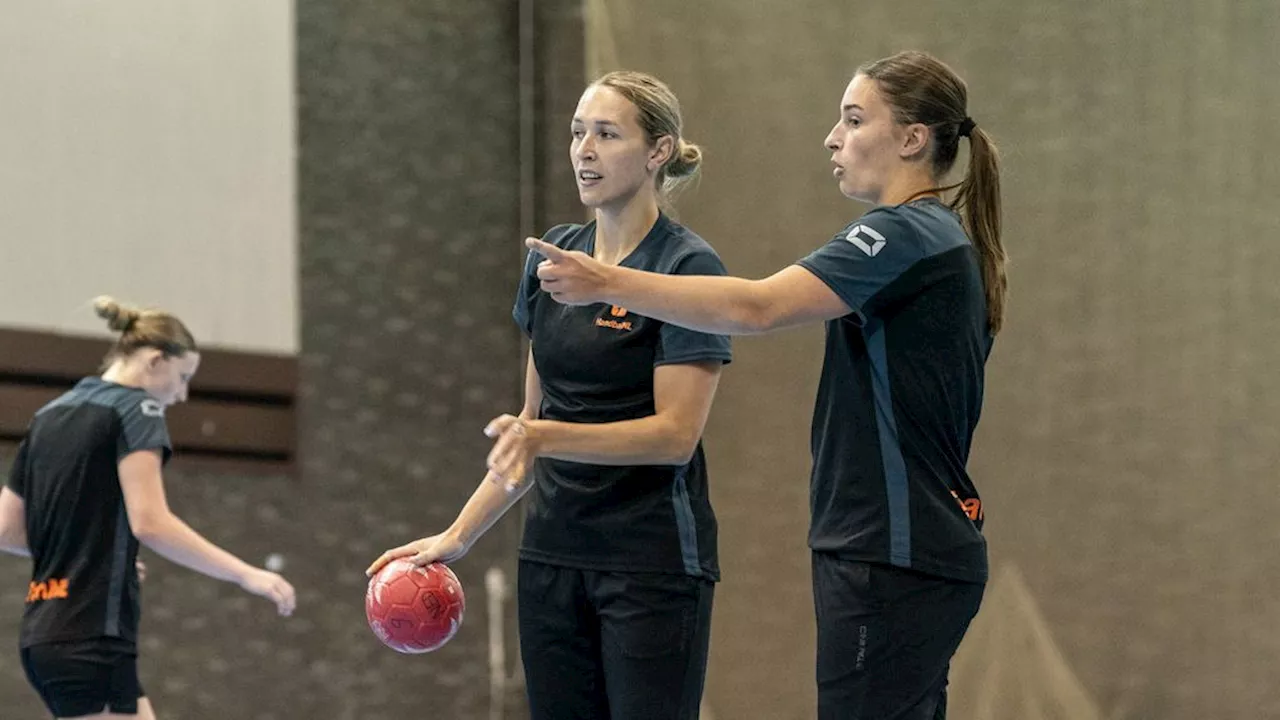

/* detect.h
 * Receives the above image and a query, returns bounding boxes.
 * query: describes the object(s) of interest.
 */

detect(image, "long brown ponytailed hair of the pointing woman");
[856,51,1009,334]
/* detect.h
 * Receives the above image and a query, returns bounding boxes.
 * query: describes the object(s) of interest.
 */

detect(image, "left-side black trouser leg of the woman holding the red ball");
[516,560,609,720]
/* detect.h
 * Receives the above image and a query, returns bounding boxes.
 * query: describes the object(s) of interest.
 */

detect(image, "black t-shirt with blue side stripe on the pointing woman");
[799,200,992,582]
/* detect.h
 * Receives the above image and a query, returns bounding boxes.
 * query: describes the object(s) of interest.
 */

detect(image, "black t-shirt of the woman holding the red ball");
[512,215,730,580]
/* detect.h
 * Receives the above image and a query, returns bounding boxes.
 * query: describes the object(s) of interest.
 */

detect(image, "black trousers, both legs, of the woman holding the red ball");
[517,560,716,720]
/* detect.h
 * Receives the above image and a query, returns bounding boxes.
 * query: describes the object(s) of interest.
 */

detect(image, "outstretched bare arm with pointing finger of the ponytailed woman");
[526,238,852,334]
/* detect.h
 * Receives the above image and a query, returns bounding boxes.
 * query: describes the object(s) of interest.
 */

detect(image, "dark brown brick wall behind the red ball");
[0,0,580,720]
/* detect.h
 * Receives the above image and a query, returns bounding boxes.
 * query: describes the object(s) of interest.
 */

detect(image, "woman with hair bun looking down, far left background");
[0,297,294,720]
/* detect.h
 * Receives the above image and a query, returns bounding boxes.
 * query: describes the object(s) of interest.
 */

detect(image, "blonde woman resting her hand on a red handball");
[369,72,730,720]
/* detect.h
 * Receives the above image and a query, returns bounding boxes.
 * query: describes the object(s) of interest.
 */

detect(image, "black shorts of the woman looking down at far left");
[22,638,143,717]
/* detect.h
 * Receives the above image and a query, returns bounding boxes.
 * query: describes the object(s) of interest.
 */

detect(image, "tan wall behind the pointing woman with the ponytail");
[589,0,1280,720]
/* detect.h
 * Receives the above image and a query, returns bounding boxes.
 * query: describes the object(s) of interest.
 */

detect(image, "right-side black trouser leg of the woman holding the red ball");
[589,573,716,720]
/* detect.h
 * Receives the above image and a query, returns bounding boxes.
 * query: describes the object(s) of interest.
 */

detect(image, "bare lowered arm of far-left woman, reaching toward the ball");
[119,450,294,615]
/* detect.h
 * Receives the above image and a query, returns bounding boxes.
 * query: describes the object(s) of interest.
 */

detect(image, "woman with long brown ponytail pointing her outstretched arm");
[527,53,1006,720]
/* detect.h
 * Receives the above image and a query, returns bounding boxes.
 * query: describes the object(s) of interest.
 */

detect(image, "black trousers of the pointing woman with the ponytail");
[813,552,984,720]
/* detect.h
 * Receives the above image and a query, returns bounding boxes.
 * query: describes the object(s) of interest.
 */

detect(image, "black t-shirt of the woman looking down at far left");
[9,378,172,647]
